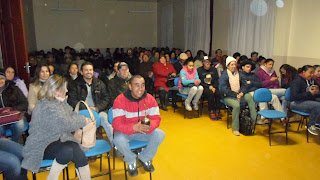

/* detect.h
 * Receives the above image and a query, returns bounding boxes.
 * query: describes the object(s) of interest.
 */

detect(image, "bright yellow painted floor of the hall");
[4,105,320,180]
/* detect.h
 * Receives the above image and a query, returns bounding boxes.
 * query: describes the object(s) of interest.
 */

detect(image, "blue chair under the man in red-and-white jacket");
[108,108,152,179]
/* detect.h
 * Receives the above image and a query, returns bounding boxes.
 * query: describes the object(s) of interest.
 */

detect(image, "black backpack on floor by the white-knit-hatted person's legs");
[239,109,253,136]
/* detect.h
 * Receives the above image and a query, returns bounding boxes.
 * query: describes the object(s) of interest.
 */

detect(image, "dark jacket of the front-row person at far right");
[290,75,320,101]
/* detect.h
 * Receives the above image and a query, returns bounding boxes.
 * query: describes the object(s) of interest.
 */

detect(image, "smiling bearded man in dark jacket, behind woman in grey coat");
[68,62,113,142]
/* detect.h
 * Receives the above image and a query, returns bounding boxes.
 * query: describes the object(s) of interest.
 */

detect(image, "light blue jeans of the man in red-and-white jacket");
[113,128,165,164]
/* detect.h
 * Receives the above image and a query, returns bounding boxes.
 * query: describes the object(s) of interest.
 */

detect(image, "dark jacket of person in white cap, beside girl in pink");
[197,66,219,89]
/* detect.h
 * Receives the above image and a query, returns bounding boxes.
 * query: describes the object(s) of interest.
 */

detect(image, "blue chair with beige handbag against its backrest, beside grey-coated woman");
[79,110,111,180]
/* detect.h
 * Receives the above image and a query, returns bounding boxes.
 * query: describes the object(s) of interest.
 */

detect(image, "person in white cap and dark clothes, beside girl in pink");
[197,56,221,120]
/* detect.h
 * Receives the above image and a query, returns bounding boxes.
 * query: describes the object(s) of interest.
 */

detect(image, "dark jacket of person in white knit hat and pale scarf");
[219,69,245,98]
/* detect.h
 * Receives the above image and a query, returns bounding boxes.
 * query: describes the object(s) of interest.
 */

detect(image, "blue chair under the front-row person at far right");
[285,88,310,142]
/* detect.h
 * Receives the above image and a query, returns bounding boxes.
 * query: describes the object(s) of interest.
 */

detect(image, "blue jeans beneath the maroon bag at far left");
[0,119,25,142]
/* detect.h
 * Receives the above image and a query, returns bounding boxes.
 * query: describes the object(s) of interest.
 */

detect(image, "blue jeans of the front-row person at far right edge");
[290,101,320,127]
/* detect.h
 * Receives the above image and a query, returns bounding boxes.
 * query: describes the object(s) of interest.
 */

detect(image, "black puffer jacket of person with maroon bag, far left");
[0,81,28,111]
